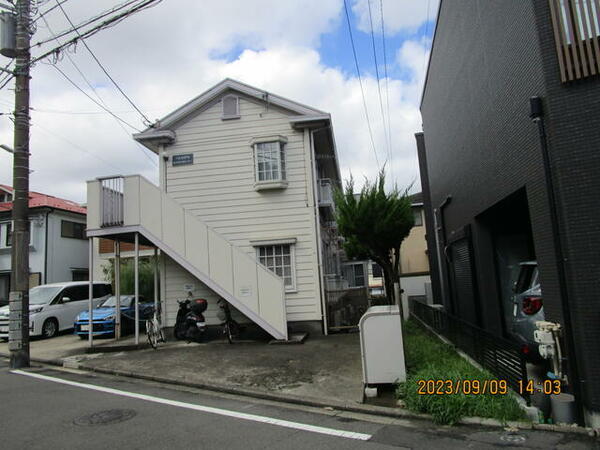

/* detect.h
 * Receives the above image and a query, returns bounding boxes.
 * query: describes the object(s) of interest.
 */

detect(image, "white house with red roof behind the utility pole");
[0,185,88,306]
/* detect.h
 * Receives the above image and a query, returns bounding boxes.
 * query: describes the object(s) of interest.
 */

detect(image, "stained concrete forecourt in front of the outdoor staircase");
[0,333,363,404]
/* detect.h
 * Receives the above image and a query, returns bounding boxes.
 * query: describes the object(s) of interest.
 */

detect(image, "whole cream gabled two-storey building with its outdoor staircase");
[87,79,341,339]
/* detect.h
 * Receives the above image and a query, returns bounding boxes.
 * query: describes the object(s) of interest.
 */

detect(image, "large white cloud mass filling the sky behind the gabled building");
[0,0,423,201]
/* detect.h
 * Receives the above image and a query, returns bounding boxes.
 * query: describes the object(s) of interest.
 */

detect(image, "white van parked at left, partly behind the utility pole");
[0,281,112,339]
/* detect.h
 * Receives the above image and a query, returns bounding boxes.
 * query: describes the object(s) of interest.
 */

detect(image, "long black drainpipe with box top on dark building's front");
[529,97,583,425]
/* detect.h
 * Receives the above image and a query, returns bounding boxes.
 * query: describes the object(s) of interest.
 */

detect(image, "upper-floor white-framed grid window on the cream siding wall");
[252,136,287,190]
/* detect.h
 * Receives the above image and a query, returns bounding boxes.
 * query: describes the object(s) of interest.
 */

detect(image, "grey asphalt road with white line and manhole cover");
[0,359,600,450]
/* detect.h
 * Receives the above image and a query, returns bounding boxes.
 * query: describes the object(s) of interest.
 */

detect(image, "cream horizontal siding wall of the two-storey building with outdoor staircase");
[161,93,321,321]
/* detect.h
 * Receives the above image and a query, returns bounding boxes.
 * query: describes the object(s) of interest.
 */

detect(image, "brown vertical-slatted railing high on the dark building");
[548,0,600,83]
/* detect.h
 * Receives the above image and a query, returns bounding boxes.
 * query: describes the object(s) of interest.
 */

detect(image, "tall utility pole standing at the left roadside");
[8,0,31,369]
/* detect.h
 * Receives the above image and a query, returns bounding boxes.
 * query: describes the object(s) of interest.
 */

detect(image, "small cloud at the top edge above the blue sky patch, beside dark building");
[352,0,439,36]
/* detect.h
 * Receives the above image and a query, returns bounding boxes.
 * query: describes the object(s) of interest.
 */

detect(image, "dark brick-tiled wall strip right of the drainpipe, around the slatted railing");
[535,1,600,411]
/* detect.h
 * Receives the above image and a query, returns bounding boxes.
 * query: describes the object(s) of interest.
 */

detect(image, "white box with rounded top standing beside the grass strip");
[358,305,406,385]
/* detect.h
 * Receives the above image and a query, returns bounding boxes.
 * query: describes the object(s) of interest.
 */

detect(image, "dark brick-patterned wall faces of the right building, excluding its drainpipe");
[421,0,600,411]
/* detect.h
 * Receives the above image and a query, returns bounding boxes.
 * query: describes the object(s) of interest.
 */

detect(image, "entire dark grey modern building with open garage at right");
[416,0,600,426]
